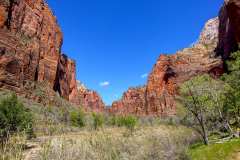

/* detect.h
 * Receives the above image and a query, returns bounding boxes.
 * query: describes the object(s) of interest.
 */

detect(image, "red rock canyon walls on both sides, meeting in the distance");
[0,0,240,116]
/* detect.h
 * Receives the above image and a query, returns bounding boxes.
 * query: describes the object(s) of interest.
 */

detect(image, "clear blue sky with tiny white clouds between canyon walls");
[47,0,223,104]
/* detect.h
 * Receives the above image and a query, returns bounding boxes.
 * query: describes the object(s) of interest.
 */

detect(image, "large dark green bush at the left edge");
[0,94,33,141]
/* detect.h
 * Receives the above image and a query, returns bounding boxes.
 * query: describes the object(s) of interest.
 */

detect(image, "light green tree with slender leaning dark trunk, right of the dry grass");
[180,75,232,145]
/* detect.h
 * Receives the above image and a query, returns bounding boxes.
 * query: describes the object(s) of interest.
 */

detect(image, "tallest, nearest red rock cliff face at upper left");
[0,0,62,88]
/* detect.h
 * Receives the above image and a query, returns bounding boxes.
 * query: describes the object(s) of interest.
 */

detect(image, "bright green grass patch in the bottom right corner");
[189,139,240,160]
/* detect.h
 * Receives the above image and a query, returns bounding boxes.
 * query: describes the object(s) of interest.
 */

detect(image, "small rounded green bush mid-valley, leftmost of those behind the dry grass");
[70,109,86,128]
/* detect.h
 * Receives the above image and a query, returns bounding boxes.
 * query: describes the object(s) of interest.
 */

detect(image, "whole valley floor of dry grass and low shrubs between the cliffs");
[0,89,199,160]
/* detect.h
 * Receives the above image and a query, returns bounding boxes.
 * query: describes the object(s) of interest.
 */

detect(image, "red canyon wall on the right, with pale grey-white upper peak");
[110,0,240,116]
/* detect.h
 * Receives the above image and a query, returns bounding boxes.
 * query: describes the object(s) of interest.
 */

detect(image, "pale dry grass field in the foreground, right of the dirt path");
[37,126,196,160]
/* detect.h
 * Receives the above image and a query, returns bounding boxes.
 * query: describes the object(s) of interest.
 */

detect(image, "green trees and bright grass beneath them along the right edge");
[178,51,240,159]
